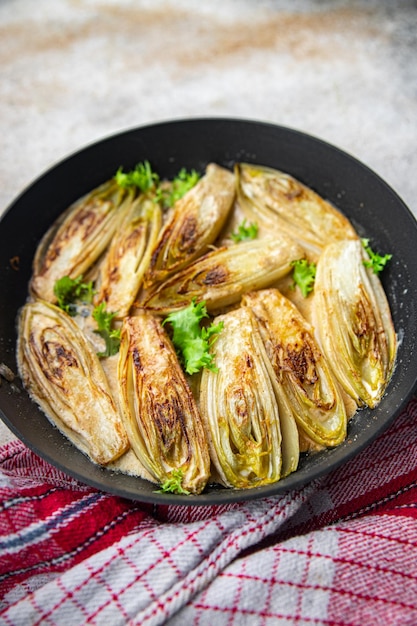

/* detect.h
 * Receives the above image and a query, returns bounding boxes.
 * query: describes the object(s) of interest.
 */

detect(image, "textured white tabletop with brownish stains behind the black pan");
[0,0,417,442]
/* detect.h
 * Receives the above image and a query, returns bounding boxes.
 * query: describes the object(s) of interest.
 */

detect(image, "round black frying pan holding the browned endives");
[0,119,417,505]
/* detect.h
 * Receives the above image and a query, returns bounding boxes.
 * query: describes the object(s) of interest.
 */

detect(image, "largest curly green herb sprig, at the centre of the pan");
[163,298,223,374]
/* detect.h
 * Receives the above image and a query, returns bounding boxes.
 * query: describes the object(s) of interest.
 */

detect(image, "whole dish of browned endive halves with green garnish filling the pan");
[17,161,397,496]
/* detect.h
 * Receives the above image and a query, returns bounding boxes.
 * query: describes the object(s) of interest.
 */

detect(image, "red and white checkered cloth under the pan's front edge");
[0,399,417,626]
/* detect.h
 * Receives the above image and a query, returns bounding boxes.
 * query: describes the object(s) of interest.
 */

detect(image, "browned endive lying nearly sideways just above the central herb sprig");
[142,236,303,314]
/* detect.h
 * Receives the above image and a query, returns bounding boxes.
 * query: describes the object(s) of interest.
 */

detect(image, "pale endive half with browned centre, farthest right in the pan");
[313,241,397,408]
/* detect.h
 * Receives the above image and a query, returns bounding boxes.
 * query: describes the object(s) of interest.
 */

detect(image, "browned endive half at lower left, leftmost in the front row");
[18,300,129,464]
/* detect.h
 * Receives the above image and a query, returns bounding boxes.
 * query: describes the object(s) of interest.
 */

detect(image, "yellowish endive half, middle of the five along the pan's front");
[200,308,299,489]
